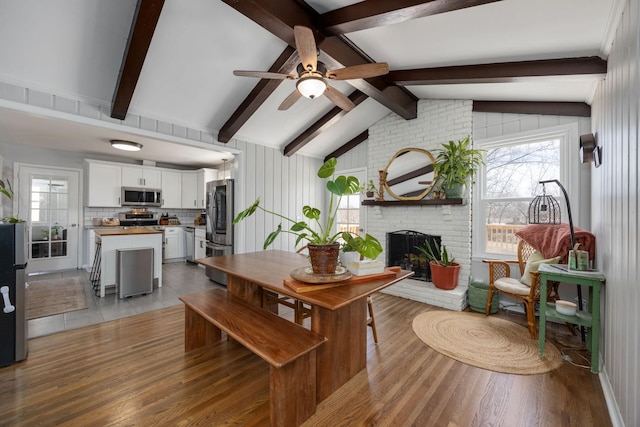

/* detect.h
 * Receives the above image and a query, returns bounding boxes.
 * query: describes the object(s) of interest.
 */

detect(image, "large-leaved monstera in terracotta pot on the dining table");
[233,158,382,274]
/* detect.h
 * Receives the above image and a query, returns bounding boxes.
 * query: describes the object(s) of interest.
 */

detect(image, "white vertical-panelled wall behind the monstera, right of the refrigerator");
[229,140,326,253]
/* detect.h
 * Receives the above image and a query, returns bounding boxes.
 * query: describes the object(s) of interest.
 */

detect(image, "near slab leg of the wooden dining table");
[311,297,367,402]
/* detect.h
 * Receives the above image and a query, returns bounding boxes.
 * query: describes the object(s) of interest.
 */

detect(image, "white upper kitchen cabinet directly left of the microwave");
[85,161,122,207]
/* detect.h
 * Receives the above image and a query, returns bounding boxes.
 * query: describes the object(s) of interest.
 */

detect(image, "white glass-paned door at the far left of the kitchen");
[14,164,81,274]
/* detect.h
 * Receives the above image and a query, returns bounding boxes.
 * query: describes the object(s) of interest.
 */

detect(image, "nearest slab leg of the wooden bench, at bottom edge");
[269,350,316,426]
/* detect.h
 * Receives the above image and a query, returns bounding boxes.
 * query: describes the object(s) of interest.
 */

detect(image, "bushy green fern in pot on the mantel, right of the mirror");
[433,136,484,199]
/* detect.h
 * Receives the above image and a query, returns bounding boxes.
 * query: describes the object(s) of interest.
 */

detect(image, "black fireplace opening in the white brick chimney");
[386,230,441,282]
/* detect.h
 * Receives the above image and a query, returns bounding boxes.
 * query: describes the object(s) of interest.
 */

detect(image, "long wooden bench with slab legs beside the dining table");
[180,289,326,426]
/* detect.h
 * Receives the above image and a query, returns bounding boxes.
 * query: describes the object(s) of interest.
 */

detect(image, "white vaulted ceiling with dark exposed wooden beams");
[0,0,623,165]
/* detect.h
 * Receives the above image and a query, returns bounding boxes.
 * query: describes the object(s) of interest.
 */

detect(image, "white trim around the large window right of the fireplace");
[472,123,580,261]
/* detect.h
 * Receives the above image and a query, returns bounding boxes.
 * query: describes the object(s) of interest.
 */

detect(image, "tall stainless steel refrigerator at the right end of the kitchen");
[206,179,233,286]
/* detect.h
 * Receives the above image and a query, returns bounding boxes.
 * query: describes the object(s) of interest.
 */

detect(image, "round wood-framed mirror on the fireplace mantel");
[384,148,437,200]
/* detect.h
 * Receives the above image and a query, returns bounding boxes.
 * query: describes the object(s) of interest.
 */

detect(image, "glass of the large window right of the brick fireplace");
[473,125,569,256]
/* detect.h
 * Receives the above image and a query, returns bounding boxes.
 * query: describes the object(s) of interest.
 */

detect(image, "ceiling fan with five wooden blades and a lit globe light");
[233,25,389,111]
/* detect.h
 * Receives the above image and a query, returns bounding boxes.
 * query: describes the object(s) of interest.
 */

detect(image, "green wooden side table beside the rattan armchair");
[538,264,605,374]
